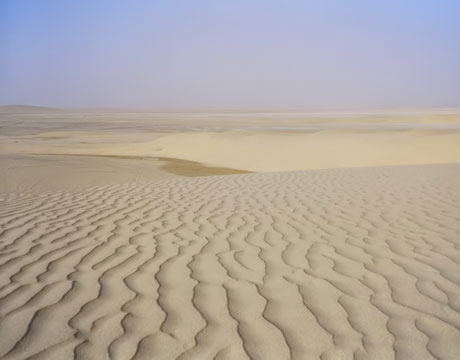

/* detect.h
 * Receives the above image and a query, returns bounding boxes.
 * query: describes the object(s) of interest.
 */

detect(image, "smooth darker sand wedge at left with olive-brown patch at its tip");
[0,154,247,193]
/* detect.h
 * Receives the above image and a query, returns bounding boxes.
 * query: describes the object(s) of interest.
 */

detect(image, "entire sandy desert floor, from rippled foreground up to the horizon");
[0,107,460,360]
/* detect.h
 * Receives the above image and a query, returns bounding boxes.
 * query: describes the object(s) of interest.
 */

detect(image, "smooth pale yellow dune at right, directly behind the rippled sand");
[150,129,460,172]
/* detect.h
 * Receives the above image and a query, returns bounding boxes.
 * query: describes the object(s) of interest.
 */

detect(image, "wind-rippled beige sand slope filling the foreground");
[0,165,460,360]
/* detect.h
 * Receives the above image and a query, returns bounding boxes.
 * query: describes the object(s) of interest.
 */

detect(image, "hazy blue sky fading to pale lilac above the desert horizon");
[0,0,460,108]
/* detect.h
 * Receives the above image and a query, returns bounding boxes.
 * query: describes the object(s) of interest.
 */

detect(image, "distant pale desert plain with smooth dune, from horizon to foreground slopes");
[0,108,460,175]
